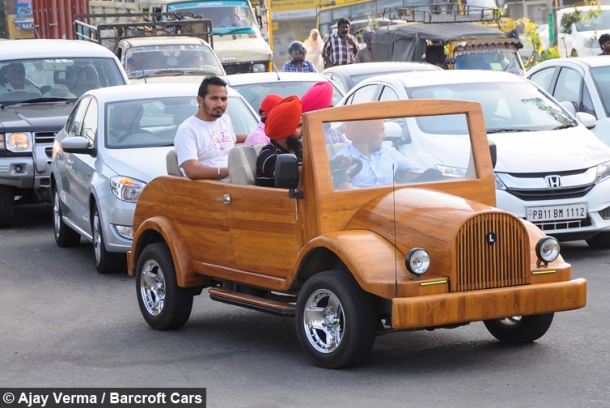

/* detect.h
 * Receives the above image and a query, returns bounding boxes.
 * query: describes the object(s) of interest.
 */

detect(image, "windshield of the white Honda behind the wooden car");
[407,81,576,134]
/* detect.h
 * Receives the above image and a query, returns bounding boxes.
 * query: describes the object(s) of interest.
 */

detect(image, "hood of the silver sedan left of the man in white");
[103,146,174,183]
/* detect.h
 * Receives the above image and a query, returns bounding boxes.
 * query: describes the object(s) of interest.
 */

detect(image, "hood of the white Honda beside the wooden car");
[489,125,610,174]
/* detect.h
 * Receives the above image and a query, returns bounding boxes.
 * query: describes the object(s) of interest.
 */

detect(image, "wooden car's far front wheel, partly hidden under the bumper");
[483,313,555,344]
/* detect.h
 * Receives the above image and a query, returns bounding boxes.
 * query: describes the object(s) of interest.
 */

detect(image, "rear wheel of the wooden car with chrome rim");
[136,242,194,330]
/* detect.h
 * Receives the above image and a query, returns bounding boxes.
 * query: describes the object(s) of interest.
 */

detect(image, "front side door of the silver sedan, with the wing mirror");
[66,98,99,233]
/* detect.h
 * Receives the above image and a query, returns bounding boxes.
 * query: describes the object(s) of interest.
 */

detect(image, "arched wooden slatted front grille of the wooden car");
[450,213,530,292]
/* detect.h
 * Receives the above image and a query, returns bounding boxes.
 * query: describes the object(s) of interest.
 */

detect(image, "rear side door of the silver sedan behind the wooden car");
[57,98,91,223]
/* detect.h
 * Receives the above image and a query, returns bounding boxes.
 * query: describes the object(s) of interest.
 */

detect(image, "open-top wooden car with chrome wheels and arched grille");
[128,99,586,368]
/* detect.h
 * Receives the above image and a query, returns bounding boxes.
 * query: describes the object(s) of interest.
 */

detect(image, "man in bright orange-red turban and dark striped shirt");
[256,95,303,187]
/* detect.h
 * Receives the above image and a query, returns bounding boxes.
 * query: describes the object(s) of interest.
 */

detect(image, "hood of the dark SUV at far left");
[0,102,74,131]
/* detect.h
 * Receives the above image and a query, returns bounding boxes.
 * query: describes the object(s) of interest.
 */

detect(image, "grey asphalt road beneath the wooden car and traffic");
[0,205,610,408]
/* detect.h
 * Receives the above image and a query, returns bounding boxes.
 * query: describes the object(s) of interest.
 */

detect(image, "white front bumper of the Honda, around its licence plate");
[496,186,610,240]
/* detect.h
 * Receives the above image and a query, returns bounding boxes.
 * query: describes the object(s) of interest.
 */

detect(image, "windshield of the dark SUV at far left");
[0,58,125,103]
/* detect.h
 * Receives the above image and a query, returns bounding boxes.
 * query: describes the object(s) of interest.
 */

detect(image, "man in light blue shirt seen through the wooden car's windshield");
[333,119,423,189]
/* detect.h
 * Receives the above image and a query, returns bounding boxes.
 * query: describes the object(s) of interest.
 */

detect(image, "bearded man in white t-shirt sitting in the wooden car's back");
[174,76,246,180]
